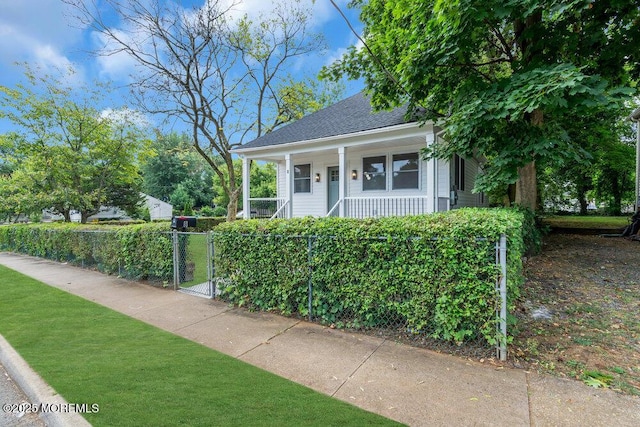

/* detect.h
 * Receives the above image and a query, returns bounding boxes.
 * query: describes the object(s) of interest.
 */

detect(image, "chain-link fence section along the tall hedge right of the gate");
[212,234,507,360]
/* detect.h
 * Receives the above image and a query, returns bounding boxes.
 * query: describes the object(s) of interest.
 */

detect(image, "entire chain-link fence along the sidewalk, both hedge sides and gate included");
[2,226,507,359]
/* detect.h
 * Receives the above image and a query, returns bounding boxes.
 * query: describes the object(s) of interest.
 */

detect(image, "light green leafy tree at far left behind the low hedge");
[0,69,148,222]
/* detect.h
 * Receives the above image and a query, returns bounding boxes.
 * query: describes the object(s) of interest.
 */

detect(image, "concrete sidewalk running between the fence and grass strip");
[0,253,640,426]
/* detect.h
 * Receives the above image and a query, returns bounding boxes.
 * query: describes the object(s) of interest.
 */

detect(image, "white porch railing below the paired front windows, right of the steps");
[327,196,429,218]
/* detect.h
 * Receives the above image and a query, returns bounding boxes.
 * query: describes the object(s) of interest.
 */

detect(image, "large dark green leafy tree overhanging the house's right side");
[323,0,640,208]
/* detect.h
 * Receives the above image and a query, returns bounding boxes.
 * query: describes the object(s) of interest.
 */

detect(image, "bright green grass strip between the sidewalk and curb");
[0,266,397,426]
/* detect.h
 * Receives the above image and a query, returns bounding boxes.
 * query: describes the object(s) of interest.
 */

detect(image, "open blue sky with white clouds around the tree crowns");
[0,0,362,133]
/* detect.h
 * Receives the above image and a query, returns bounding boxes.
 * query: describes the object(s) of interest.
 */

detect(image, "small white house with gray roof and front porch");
[234,93,488,218]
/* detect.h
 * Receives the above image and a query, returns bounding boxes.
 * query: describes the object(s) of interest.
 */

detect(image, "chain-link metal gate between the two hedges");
[173,230,215,298]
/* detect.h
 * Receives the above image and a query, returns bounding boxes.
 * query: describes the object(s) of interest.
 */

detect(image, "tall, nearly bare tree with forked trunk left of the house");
[64,0,338,220]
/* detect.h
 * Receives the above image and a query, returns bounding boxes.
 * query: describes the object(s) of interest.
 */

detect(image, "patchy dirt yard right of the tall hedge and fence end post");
[510,234,640,395]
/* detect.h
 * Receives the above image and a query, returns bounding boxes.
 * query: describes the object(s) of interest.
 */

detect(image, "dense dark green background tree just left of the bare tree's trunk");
[142,133,215,207]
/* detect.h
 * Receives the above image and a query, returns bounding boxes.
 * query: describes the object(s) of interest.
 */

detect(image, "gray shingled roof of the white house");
[237,92,408,151]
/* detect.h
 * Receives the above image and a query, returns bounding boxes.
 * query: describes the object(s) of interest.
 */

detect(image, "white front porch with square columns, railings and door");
[242,129,450,219]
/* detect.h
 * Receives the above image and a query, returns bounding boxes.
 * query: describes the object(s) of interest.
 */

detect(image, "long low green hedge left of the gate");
[0,223,173,282]
